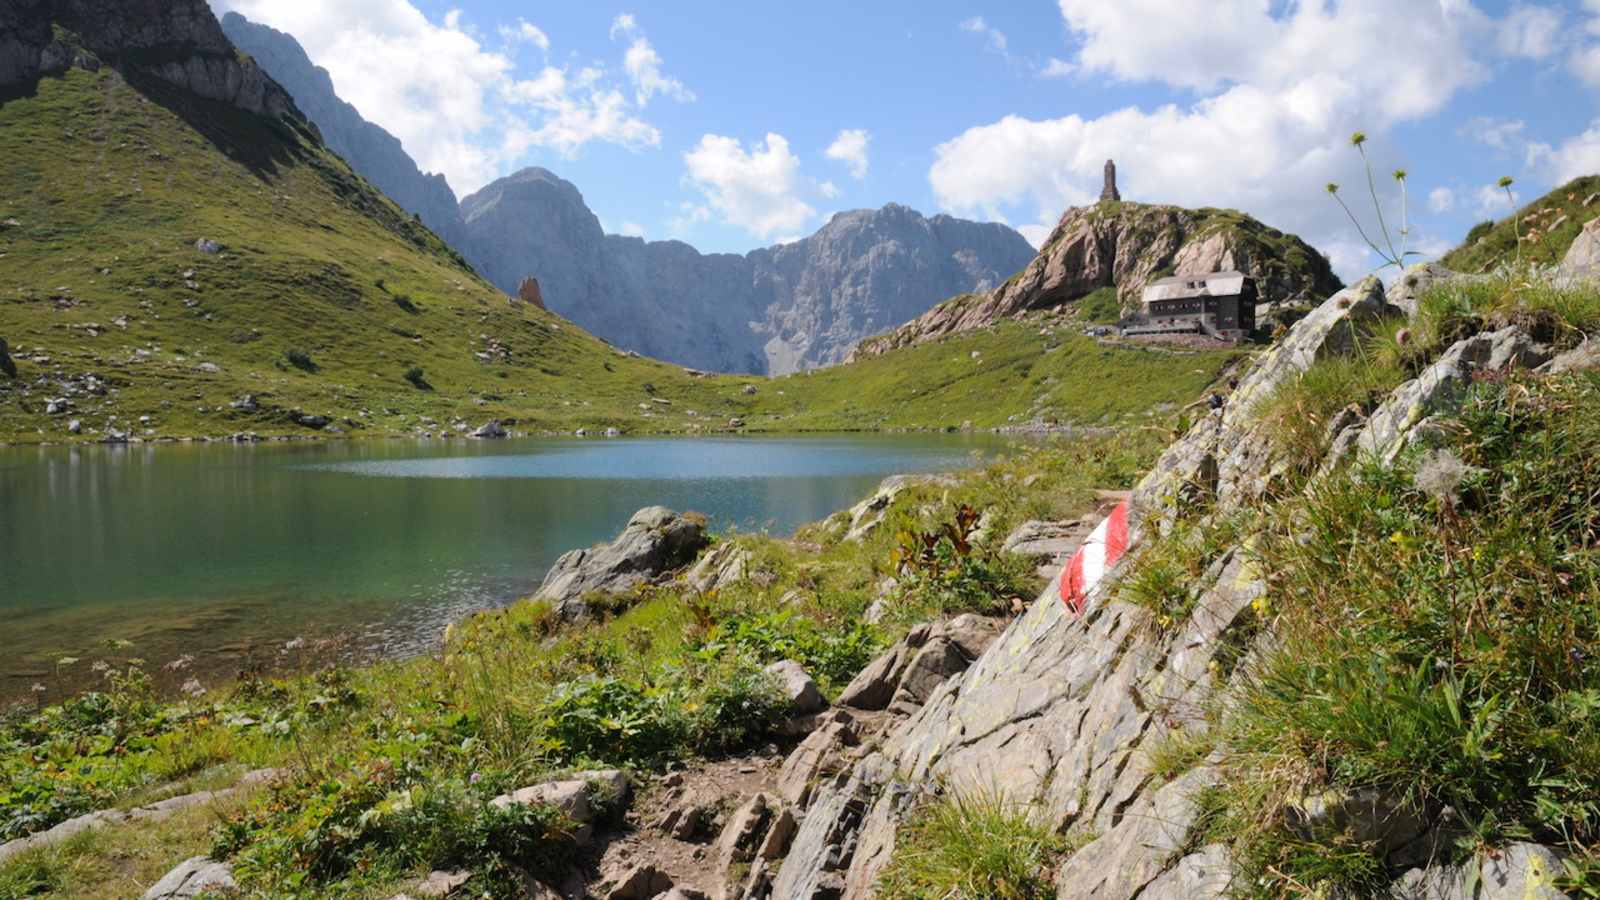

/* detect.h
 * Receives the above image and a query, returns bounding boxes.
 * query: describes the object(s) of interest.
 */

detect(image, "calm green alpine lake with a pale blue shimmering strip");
[0,434,1014,705]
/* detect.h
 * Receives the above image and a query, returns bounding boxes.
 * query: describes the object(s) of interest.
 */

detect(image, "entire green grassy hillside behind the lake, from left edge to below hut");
[0,70,1222,440]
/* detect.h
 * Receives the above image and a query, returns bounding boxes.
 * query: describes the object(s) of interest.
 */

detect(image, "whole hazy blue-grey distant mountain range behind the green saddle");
[222,13,1034,375]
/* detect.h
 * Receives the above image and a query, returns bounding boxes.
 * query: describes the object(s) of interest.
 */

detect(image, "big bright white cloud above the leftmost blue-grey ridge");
[211,0,661,194]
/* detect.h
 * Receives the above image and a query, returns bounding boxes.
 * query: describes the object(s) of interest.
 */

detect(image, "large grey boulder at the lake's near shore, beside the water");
[534,506,707,621]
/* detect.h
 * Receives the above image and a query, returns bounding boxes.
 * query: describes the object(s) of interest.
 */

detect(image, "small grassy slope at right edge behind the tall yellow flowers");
[1438,175,1600,272]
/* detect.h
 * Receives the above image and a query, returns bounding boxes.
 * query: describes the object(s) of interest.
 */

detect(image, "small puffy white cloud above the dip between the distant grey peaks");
[683,135,816,239]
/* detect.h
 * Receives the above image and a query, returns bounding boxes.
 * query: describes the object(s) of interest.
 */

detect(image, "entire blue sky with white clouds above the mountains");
[213,0,1600,277]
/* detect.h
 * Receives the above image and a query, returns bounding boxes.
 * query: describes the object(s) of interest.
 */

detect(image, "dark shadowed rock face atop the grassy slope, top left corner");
[0,0,299,117]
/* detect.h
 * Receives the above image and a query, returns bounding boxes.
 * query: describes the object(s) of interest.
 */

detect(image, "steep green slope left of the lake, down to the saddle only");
[0,70,748,439]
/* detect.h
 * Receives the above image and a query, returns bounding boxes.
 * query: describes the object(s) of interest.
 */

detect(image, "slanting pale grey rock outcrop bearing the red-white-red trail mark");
[773,265,1560,900]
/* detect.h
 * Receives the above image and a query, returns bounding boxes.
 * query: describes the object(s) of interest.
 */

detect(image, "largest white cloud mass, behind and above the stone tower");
[928,0,1496,274]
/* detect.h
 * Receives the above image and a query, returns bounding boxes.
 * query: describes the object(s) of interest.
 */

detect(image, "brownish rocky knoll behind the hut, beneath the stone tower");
[851,203,1341,359]
